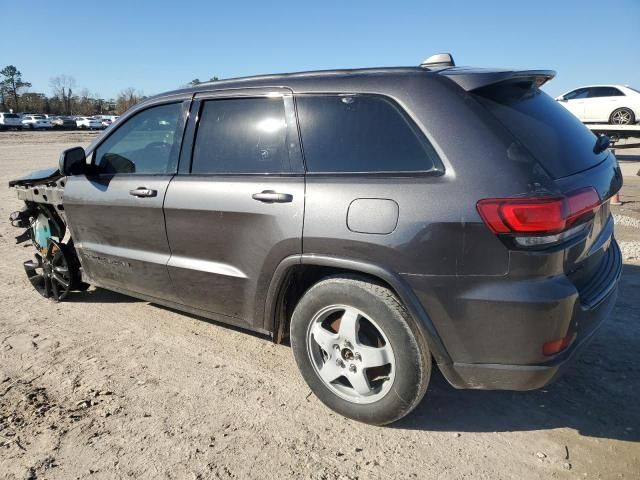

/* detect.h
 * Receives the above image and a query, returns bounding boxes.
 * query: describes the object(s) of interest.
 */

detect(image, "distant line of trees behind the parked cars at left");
[0,65,146,116]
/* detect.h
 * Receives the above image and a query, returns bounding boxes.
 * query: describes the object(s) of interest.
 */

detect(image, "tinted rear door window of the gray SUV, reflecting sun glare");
[191,97,291,174]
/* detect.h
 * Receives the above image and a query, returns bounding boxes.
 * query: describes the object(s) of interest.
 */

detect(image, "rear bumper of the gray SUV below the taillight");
[414,239,622,390]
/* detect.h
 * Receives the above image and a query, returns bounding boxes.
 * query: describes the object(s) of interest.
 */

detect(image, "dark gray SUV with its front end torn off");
[11,55,622,424]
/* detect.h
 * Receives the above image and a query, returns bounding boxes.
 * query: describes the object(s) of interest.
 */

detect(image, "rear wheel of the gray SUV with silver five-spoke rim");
[290,275,431,425]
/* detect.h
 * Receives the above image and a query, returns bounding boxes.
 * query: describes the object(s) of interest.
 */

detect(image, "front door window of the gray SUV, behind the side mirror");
[94,103,184,175]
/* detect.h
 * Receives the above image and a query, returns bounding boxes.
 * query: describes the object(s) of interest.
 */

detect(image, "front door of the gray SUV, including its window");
[64,99,189,301]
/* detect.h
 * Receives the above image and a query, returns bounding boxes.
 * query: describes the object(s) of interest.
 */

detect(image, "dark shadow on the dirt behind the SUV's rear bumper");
[393,265,640,442]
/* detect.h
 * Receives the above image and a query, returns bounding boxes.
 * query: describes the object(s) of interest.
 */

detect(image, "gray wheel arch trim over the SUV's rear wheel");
[264,254,451,364]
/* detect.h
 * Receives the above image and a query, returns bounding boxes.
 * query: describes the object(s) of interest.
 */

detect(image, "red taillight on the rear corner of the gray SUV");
[477,187,601,247]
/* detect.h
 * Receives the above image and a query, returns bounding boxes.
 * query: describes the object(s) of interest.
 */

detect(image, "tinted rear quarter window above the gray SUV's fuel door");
[296,95,436,172]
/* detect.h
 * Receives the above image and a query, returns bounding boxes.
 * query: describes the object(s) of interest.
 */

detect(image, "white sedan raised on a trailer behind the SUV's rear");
[556,85,640,125]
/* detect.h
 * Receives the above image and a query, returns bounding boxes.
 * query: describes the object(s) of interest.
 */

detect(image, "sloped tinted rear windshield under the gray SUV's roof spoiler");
[474,82,608,178]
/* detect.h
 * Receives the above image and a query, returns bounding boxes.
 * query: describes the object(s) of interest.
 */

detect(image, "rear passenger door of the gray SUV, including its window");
[164,88,305,330]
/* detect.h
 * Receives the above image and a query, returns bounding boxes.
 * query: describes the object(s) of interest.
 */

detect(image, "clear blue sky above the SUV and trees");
[0,0,640,98]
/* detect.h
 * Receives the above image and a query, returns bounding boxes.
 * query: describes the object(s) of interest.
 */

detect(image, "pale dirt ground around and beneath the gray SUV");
[0,132,640,479]
